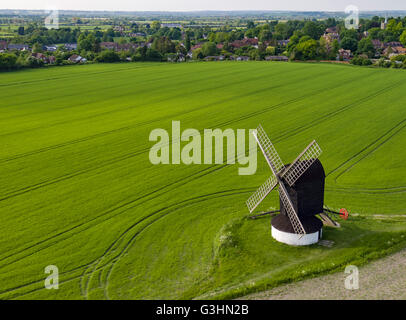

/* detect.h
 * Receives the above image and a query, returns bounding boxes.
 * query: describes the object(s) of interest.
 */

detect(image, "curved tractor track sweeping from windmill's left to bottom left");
[0,188,252,299]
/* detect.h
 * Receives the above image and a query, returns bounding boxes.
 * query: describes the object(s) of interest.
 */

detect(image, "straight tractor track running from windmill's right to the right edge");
[327,118,406,182]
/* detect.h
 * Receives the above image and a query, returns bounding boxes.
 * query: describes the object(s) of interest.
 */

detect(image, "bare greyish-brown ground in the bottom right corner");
[242,249,406,300]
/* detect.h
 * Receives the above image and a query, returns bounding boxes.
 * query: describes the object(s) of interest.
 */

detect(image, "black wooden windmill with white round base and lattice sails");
[247,125,326,245]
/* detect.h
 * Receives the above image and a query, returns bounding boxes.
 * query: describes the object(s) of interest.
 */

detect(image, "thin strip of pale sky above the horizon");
[0,0,406,11]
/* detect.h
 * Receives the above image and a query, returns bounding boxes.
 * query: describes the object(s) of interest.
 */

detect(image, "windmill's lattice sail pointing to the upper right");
[282,141,322,186]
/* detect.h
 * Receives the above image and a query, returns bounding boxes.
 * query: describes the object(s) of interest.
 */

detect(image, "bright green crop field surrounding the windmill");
[0,62,406,299]
